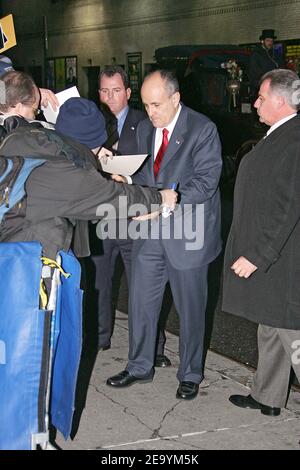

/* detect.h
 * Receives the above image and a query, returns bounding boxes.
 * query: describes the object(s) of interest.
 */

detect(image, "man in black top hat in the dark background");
[249,29,279,98]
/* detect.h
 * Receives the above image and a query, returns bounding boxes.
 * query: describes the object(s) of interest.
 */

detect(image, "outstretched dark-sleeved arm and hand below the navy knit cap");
[26,159,177,220]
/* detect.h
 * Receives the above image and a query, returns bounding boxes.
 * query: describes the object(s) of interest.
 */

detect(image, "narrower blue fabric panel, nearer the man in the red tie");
[50,252,82,439]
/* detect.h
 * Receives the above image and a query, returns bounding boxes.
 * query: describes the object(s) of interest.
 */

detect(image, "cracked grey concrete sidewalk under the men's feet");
[56,312,300,451]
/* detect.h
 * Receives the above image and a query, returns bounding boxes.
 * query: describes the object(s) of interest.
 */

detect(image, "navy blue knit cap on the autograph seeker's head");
[55,97,107,149]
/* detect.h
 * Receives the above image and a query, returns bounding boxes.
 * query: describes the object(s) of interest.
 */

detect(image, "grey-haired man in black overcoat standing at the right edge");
[222,69,300,416]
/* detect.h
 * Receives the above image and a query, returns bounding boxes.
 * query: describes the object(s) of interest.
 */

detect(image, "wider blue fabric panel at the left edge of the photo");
[0,242,46,450]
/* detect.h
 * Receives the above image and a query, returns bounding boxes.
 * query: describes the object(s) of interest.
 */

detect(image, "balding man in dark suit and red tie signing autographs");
[107,70,222,399]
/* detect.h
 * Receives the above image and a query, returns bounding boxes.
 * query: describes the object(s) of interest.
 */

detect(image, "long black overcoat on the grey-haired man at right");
[222,116,300,329]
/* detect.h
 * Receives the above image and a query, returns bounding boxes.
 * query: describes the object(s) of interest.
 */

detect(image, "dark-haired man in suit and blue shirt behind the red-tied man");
[92,65,171,367]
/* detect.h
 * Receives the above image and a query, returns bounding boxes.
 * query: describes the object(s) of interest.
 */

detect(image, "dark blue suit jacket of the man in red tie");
[133,105,222,269]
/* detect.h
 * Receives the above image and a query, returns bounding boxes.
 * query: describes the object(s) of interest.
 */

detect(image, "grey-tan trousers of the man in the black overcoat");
[251,325,300,408]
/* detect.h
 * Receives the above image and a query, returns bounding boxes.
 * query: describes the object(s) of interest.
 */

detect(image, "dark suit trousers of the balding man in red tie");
[126,240,208,383]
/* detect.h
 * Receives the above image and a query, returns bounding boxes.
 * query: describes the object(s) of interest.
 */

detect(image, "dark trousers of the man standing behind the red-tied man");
[91,239,166,354]
